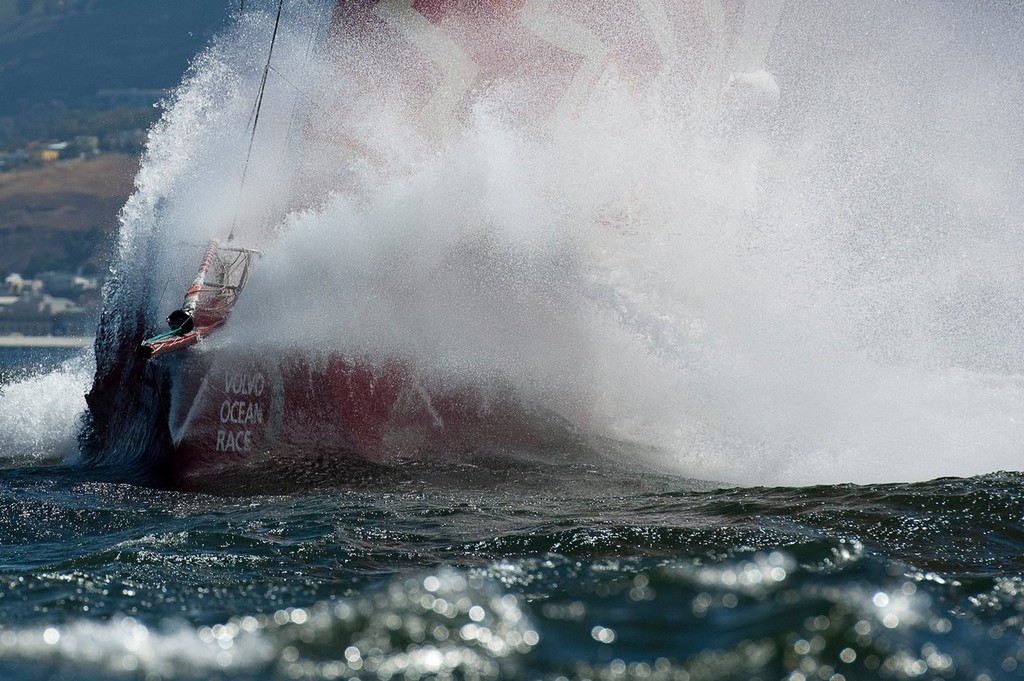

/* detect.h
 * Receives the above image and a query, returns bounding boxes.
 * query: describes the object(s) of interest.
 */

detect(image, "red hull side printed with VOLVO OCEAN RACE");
[169,350,568,492]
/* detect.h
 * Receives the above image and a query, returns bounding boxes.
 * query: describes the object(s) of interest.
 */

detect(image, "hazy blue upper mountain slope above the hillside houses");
[0,0,238,147]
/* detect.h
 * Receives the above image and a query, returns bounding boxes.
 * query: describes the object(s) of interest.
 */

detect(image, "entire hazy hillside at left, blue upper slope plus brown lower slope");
[0,0,239,274]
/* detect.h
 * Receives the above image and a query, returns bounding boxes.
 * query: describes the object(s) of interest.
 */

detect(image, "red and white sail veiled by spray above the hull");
[329,0,782,133]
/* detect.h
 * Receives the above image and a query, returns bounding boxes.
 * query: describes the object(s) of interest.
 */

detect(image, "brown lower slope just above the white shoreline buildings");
[0,154,138,274]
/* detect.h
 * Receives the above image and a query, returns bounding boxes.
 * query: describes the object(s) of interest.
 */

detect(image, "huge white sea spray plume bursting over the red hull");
[81,2,1024,489]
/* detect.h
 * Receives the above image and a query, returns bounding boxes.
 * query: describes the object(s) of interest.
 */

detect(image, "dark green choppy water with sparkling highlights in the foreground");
[0,348,1024,681]
